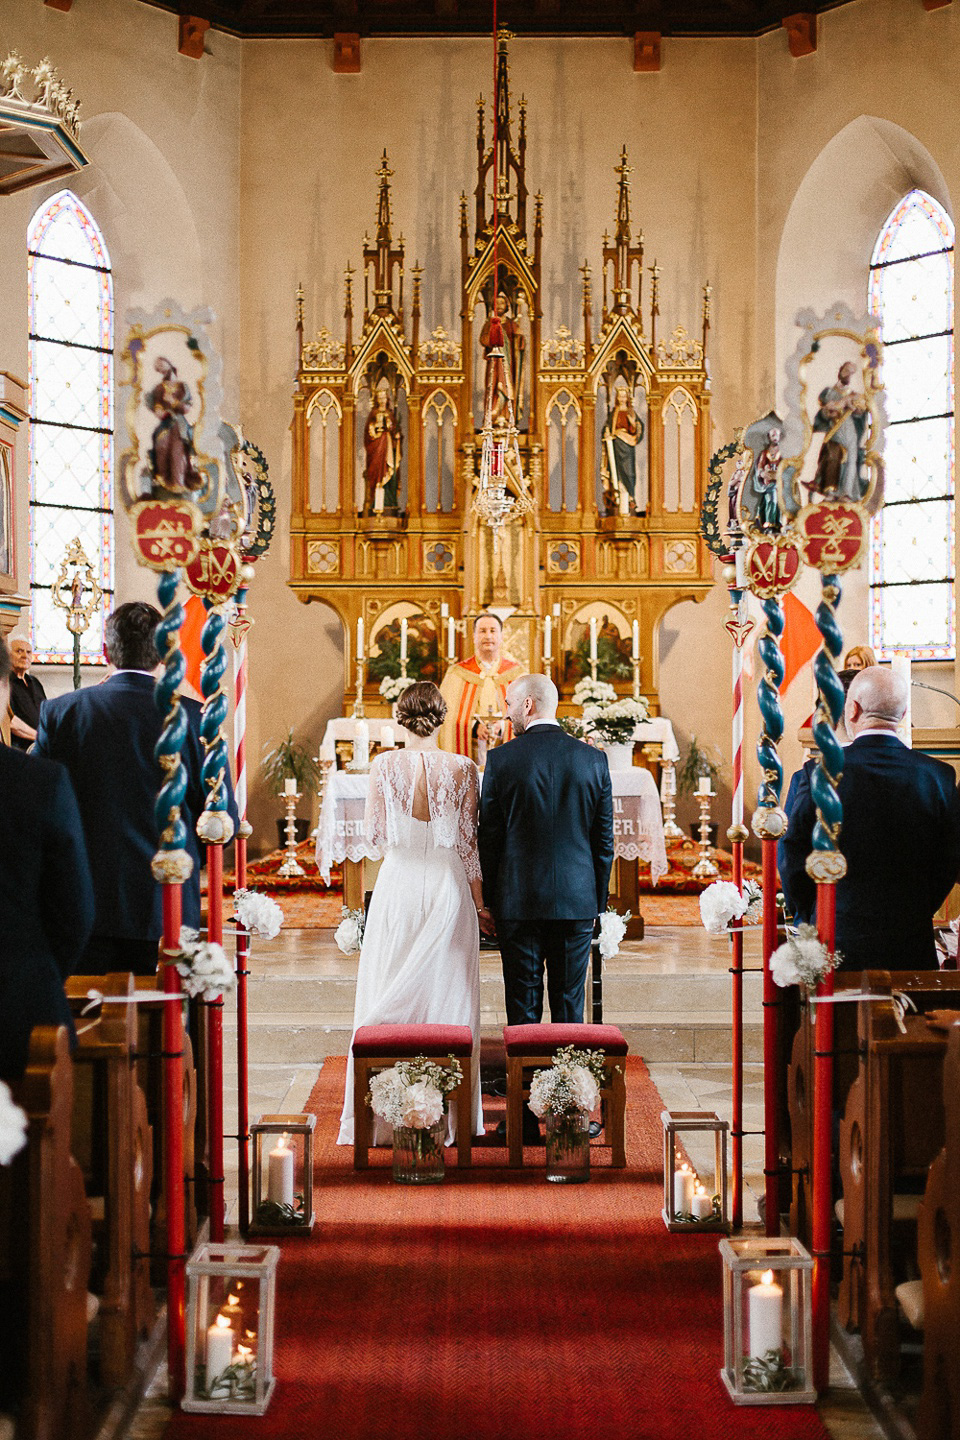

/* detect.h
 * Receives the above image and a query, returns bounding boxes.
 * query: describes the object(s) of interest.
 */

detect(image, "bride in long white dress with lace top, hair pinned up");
[337,684,492,1145]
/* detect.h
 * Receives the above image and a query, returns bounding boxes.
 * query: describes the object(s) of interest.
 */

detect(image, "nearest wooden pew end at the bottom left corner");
[0,1025,91,1440]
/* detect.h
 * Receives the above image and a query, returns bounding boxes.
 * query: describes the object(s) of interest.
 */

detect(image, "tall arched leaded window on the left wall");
[27,190,114,664]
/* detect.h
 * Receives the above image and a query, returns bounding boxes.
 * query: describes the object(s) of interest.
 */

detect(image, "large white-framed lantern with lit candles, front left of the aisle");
[181,1244,281,1416]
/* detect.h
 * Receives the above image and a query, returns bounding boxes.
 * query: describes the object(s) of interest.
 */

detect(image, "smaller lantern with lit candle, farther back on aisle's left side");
[248,1115,317,1236]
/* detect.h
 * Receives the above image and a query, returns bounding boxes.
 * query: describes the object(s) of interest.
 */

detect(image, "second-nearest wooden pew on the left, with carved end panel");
[66,973,155,1390]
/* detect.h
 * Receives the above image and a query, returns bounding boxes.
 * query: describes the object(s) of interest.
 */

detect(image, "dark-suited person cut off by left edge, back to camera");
[0,639,94,1080]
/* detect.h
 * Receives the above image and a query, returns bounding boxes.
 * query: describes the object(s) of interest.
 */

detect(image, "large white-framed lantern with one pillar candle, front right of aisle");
[720,1236,816,1405]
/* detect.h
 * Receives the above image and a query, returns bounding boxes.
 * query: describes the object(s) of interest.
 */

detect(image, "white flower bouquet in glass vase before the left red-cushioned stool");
[367,1056,469,1184]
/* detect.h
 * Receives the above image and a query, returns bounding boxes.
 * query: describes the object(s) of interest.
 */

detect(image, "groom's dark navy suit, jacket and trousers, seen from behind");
[479,723,613,1025]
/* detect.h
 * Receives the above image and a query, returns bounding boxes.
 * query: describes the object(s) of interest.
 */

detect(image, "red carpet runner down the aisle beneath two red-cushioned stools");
[167,1058,826,1440]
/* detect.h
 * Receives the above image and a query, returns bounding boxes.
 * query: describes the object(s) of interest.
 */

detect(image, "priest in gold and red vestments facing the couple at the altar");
[440,611,527,769]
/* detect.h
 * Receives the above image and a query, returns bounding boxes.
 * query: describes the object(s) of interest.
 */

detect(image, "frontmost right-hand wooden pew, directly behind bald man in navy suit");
[786,971,960,1248]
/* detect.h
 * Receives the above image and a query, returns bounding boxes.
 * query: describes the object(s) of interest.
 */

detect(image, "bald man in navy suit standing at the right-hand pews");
[779,665,960,971]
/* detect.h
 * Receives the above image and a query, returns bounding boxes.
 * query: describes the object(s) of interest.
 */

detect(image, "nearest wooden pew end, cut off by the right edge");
[917,1024,960,1440]
